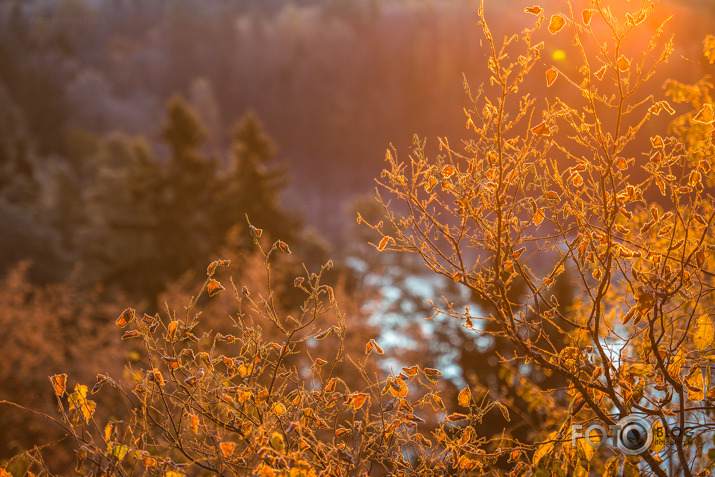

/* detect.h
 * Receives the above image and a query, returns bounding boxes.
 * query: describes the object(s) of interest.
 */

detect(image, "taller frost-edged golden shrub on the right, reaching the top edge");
[366,0,715,476]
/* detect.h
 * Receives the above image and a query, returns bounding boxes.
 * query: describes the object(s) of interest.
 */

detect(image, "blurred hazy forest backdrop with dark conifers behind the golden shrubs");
[0,0,715,468]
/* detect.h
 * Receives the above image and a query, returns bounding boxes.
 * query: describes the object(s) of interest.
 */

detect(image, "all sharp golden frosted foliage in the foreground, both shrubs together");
[0,0,715,477]
